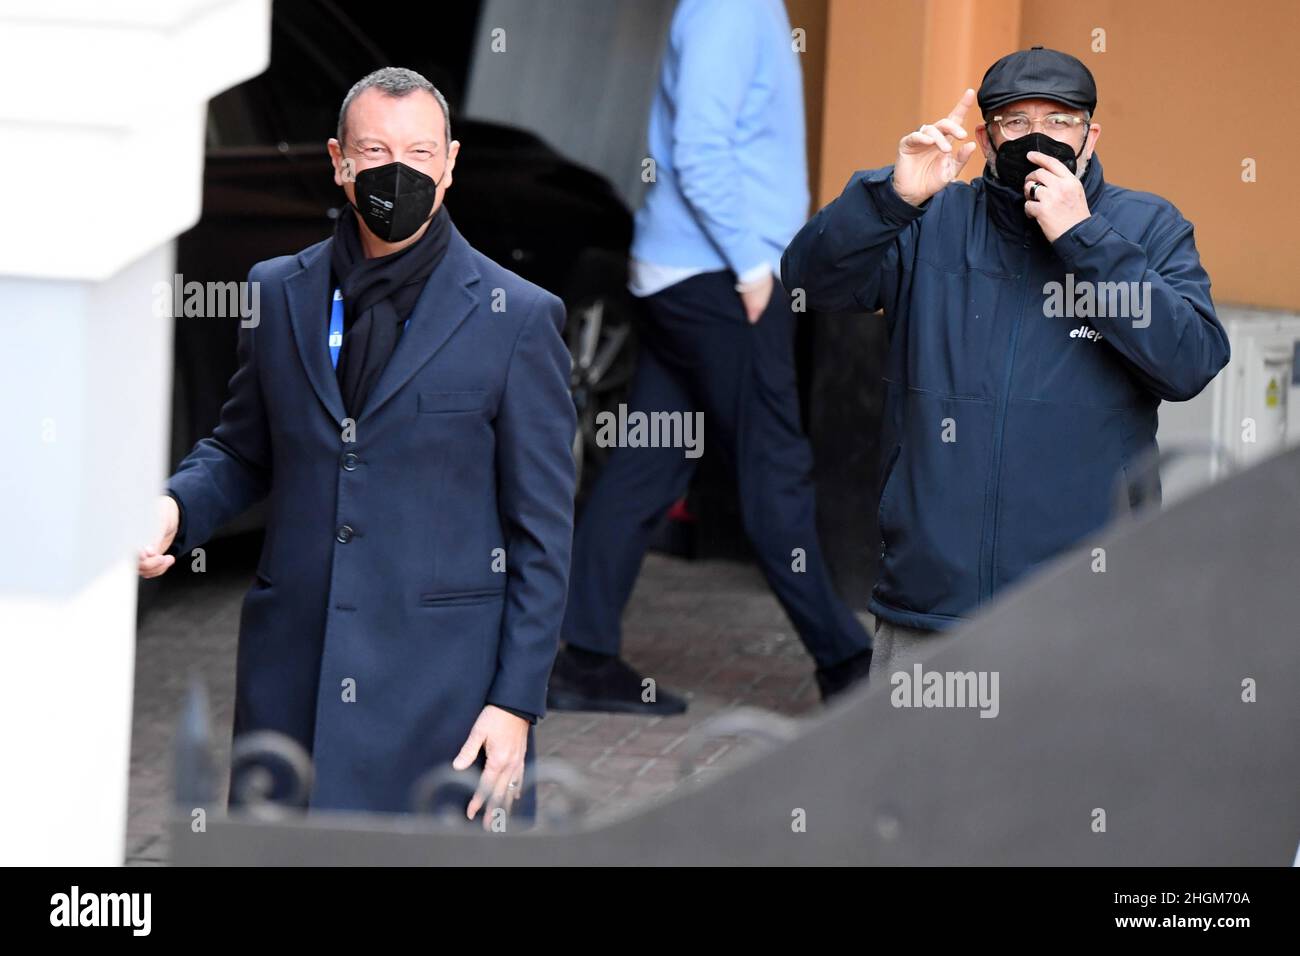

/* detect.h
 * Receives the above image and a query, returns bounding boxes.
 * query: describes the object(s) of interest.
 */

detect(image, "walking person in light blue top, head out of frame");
[549,0,871,714]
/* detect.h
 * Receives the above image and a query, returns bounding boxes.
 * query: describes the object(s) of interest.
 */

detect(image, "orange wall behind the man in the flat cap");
[806,0,1300,310]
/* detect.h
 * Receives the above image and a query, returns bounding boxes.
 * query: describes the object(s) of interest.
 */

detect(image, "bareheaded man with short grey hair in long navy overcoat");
[139,68,575,826]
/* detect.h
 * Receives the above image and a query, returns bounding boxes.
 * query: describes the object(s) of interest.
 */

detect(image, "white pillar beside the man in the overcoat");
[0,0,270,865]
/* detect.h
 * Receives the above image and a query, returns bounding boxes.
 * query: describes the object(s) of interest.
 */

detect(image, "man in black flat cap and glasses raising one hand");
[781,47,1229,671]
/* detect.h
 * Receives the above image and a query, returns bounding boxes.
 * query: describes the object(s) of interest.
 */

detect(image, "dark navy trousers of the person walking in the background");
[563,272,871,667]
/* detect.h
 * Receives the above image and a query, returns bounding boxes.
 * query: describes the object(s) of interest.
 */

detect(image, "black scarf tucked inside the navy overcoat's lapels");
[330,206,451,419]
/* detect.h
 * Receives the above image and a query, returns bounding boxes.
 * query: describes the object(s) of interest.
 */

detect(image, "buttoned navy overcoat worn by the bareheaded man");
[168,229,575,812]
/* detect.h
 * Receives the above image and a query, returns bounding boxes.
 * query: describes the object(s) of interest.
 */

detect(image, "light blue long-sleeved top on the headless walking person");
[632,0,809,303]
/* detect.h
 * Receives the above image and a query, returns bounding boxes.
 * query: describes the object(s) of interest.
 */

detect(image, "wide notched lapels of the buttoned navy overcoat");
[285,225,480,427]
